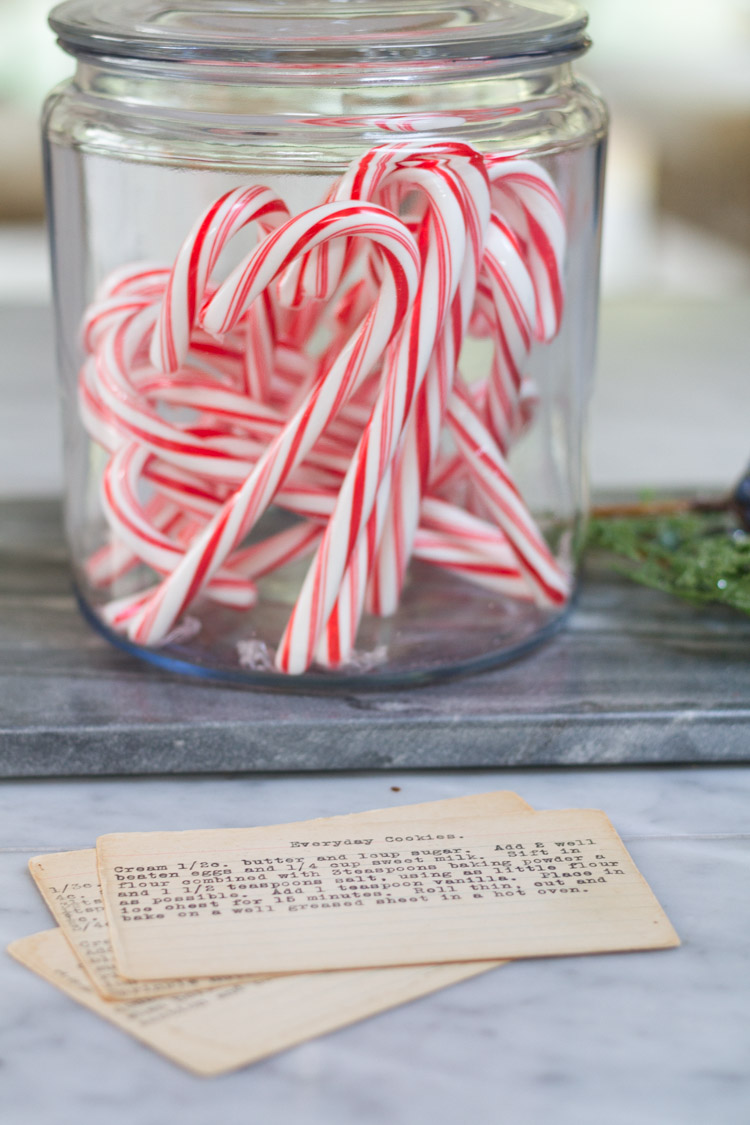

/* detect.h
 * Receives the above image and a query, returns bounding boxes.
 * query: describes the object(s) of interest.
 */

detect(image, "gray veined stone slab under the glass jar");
[0,500,750,777]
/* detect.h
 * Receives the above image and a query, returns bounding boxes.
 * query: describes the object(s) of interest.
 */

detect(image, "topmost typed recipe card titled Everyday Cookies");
[97,810,679,980]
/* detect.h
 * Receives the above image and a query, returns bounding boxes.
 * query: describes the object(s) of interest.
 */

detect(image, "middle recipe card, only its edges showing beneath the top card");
[29,790,531,1000]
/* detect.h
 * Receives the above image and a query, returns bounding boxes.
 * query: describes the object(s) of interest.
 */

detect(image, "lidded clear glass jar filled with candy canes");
[44,0,606,689]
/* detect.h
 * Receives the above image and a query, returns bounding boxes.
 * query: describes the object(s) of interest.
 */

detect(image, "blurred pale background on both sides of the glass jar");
[0,0,750,494]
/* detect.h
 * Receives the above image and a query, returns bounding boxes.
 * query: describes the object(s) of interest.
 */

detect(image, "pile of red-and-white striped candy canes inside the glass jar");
[79,142,570,673]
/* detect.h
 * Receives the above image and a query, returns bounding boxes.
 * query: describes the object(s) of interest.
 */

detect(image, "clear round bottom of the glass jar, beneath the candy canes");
[76,565,569,693]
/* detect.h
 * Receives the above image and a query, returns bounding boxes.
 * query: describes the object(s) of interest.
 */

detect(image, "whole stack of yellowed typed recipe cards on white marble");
[9,792,679,1074]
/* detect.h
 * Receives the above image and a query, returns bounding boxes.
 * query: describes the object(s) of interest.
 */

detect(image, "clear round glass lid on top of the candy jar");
[49,0,588,65]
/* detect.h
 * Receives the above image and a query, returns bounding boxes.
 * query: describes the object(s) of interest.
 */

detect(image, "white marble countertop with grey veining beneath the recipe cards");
[0,767,750,1125]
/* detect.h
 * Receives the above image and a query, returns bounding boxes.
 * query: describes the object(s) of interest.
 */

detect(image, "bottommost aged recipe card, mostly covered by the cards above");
[8,929,496,1076]
